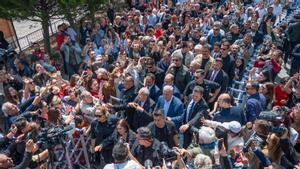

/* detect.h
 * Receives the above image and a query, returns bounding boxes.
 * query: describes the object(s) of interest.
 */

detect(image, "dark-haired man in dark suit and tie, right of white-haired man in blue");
[179,86,208,148]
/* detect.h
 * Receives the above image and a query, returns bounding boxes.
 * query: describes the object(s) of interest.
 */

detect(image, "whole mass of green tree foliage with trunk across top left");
[0,0,109,54]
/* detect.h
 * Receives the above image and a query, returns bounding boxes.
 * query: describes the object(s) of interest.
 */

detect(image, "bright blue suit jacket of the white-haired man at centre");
[156,96,183,127]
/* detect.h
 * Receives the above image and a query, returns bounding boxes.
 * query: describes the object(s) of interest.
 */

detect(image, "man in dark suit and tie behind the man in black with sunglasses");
[206,58,228,92]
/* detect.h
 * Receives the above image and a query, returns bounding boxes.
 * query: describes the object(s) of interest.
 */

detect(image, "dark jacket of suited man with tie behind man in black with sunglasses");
[205,69,229,92]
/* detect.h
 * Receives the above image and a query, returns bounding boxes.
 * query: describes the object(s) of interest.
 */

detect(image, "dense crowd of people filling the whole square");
[0,0,300,169]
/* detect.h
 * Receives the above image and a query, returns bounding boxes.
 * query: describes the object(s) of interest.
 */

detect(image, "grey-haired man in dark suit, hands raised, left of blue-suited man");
[113,87,155,131]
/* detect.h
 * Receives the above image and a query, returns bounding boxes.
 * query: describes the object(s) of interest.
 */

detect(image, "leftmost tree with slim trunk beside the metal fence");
[0,0,60,55]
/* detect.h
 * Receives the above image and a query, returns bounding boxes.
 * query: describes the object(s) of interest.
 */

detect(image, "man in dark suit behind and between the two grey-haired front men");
[144,73,161,101]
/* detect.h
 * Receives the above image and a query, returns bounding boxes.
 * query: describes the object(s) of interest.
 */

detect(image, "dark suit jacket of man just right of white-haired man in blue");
[182,98,209,128]
